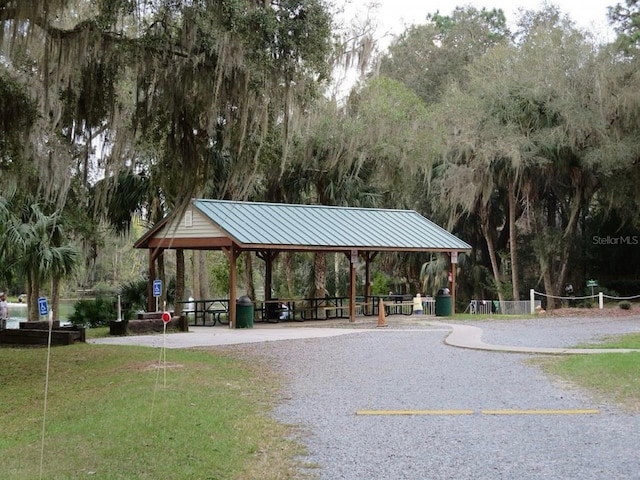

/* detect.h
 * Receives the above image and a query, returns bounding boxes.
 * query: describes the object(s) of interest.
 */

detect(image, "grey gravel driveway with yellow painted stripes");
[229,317,640,480]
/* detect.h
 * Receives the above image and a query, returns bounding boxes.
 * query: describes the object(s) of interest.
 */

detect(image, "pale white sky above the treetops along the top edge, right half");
[334,0,623,44]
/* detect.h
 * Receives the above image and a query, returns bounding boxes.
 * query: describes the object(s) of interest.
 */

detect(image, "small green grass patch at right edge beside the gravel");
[542,334,640,412]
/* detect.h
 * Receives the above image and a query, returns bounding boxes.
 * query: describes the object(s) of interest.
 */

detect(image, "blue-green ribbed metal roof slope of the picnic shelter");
[192,199,471,251]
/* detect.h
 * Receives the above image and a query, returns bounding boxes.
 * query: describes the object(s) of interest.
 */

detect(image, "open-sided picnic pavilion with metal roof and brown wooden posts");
[134,199,471,327]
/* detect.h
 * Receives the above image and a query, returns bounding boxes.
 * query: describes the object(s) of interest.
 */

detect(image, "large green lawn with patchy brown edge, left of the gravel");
[0,344,303,480]
